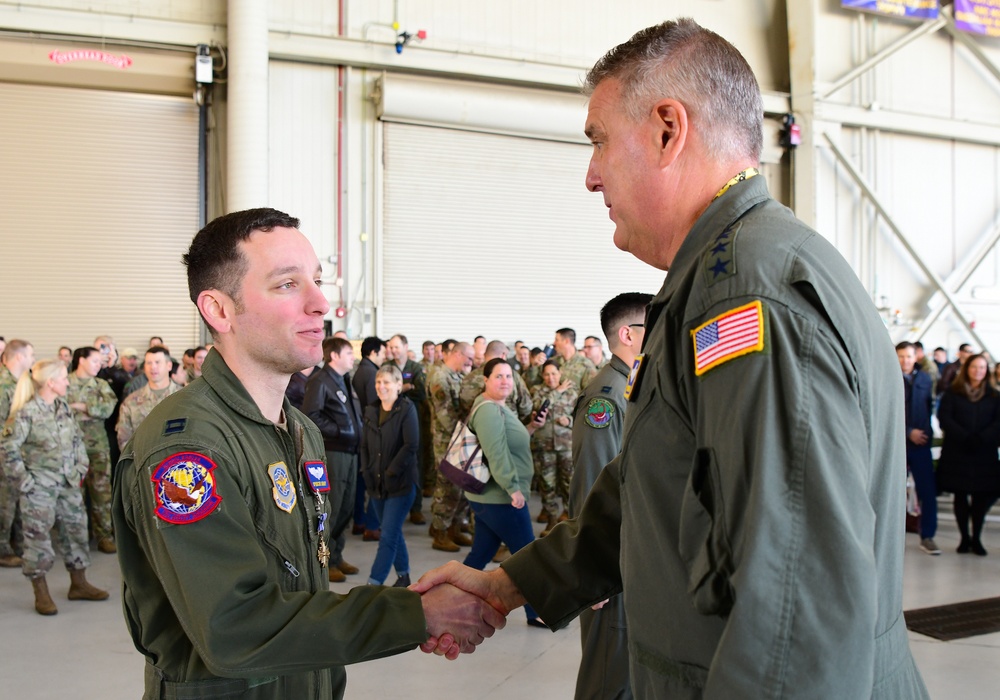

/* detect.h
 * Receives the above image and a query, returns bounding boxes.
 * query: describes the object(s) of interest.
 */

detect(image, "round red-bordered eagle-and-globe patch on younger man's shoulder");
[151,452,222,525]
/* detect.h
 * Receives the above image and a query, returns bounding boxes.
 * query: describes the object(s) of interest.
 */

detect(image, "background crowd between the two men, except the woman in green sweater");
[285,328,607,586]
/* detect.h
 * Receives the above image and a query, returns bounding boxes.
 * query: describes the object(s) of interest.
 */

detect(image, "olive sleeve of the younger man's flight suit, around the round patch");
[114,443,427,678]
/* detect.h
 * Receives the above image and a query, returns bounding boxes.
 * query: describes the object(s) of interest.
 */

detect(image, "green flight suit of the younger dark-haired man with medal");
[113,350,427,699]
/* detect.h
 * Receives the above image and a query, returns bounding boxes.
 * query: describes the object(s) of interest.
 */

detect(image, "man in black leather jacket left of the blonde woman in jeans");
[302,338,361,583]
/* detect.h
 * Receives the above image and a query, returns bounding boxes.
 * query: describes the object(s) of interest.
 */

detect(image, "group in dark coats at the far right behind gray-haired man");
[896,342,1000,556]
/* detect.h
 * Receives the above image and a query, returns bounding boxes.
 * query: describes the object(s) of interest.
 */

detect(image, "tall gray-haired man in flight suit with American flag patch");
[415,19,927,700]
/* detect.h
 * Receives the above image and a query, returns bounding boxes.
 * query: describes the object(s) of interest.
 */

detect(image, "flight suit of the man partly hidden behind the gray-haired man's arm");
[569,355,632,700]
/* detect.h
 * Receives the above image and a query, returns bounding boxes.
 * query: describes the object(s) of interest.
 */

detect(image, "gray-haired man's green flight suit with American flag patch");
[503,177,927,700]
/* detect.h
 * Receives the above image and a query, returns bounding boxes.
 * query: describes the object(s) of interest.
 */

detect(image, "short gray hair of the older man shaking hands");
[583,18,764,162]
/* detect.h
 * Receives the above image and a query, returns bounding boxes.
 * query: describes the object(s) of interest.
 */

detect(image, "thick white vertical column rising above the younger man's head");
[226,0,269,211]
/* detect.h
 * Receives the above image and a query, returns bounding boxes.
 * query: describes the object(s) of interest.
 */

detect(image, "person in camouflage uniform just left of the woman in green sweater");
[427,343,474,552]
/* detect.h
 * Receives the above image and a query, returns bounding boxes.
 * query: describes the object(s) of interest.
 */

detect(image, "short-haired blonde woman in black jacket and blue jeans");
[361,362,420,586]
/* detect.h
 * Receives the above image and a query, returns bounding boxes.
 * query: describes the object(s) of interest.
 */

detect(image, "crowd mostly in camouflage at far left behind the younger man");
[0,335,221,615]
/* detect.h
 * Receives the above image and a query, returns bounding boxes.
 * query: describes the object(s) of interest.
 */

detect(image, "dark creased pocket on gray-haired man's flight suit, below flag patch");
[679,447,733,615]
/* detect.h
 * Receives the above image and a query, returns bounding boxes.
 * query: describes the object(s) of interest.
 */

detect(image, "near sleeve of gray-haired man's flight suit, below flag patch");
[684,299,880,698]
